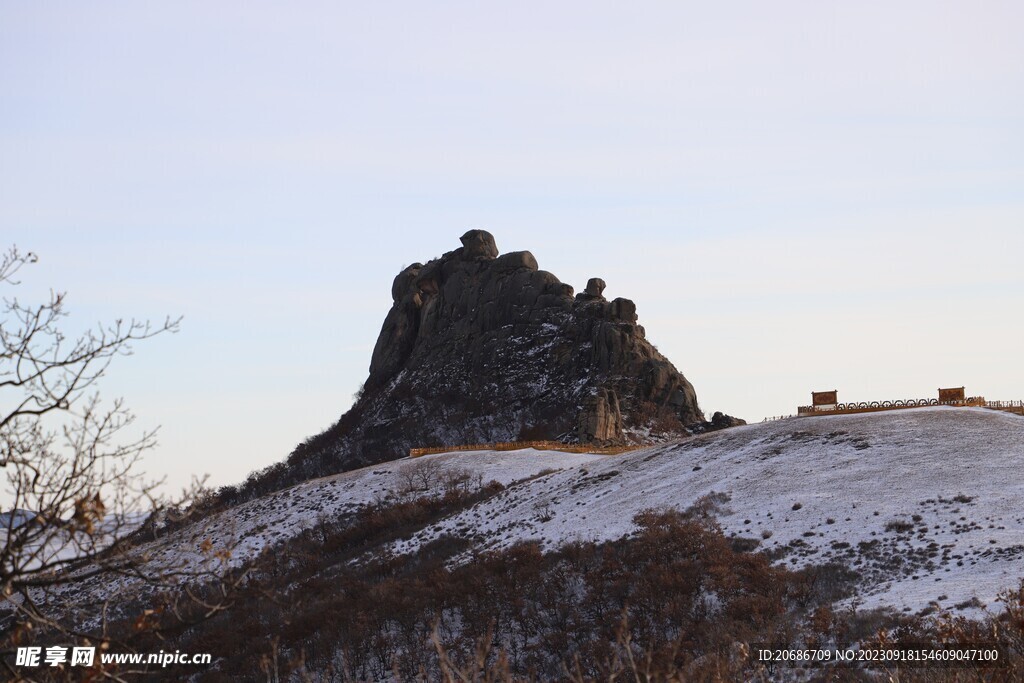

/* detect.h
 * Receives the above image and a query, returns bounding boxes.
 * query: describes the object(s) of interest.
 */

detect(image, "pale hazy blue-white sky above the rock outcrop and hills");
[0,0,1024,487]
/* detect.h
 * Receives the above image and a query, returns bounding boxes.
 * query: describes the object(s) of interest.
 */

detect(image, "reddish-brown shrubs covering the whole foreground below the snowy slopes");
[18,481,1024,683]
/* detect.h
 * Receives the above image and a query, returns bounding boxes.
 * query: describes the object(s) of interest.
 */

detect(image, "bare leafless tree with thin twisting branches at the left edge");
[0,247,239,679]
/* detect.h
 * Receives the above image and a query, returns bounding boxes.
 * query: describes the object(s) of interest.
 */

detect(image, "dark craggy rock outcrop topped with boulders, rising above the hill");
[289,230,705,476]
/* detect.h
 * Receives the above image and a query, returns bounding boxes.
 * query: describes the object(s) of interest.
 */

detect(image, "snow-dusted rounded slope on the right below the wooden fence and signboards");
[385,408,1024,611]
